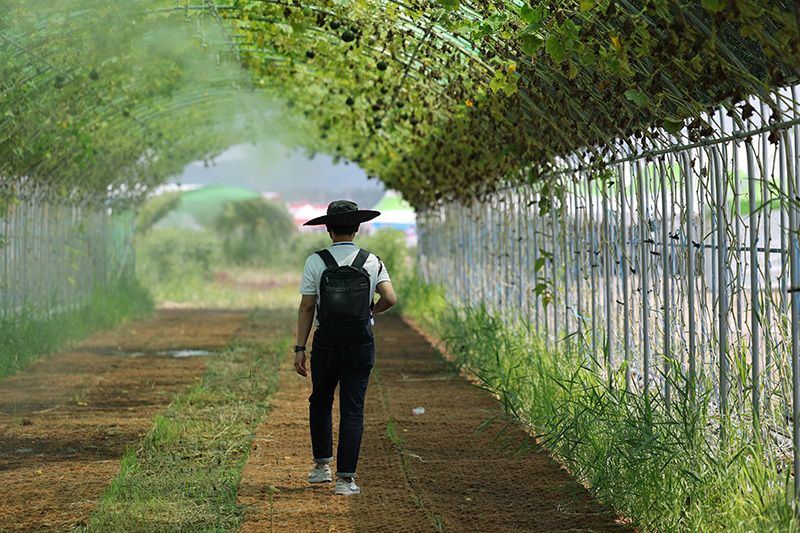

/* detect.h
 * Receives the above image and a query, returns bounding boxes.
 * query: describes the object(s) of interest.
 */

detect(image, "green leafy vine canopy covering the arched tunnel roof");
[0,0,800,208]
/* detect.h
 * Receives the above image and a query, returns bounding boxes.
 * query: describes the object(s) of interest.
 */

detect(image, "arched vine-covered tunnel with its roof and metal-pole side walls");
[0,0,800,524]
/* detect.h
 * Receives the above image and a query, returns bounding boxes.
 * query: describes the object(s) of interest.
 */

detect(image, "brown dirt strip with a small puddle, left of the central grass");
[0,310,247,531]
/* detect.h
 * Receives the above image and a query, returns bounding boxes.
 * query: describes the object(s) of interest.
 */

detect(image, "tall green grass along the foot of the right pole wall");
[406,289,800,532]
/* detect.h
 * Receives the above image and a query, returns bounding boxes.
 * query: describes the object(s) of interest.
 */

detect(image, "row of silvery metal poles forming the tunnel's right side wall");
[419,89,800,474]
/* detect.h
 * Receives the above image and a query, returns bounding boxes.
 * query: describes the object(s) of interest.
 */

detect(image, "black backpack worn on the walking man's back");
[317,249,374,346]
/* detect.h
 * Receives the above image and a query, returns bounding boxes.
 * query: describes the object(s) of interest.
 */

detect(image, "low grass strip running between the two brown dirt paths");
[82,309,295,531]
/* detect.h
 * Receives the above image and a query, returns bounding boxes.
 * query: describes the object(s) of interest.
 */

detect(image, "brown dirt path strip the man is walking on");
[239,316,632,532]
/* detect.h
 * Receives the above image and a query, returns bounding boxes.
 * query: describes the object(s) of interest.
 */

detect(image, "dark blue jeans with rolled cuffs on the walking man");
[308,330,375,477]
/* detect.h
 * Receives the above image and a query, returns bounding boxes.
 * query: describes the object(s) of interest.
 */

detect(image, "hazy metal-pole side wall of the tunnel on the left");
[0,187,136,318]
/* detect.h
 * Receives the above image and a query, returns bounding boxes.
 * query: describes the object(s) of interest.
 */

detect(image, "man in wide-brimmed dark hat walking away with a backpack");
[294,200,397,495]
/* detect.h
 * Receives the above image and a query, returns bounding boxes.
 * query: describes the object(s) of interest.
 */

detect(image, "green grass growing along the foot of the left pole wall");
[0,281,153,379]
